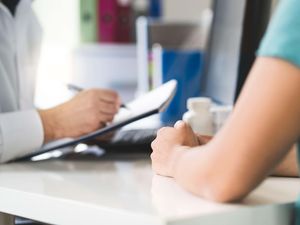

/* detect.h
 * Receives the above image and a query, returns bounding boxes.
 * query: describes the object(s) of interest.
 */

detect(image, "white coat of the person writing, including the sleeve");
[0,0,44,162]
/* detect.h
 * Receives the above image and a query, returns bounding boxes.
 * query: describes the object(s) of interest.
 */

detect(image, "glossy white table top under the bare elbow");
[0,160,300,225]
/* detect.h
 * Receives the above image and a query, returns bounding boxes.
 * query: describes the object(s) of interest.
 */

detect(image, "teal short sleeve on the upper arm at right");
[257,0,300,68]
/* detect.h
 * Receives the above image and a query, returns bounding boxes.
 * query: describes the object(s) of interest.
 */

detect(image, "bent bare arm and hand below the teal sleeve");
[151,57,300,202]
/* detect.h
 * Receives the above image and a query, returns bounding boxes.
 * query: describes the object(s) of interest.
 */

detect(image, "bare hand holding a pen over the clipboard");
[39,89,121,143]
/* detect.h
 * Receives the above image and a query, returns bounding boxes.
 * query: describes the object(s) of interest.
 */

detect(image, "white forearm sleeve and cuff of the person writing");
[0,110,44,162]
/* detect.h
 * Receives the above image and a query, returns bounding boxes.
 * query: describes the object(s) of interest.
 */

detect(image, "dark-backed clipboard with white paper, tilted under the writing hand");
[11,80,177,162]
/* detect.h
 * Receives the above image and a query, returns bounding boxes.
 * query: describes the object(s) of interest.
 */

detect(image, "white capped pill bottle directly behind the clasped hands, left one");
[183,97,214,135]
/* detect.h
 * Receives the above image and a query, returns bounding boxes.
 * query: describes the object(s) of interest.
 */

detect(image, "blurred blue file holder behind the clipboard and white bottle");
[161,50,203,125]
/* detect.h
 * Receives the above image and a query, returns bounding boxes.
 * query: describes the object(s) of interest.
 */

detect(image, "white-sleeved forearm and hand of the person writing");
[0,89,120,163]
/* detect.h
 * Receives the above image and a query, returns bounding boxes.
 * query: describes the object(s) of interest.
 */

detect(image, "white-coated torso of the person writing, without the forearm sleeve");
[0,0,41,113]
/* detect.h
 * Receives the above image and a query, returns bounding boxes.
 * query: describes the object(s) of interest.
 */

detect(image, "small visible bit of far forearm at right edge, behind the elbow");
[272,145,299,177]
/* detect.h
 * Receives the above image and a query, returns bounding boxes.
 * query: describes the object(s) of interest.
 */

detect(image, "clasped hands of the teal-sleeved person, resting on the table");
[151,121,204,177]
